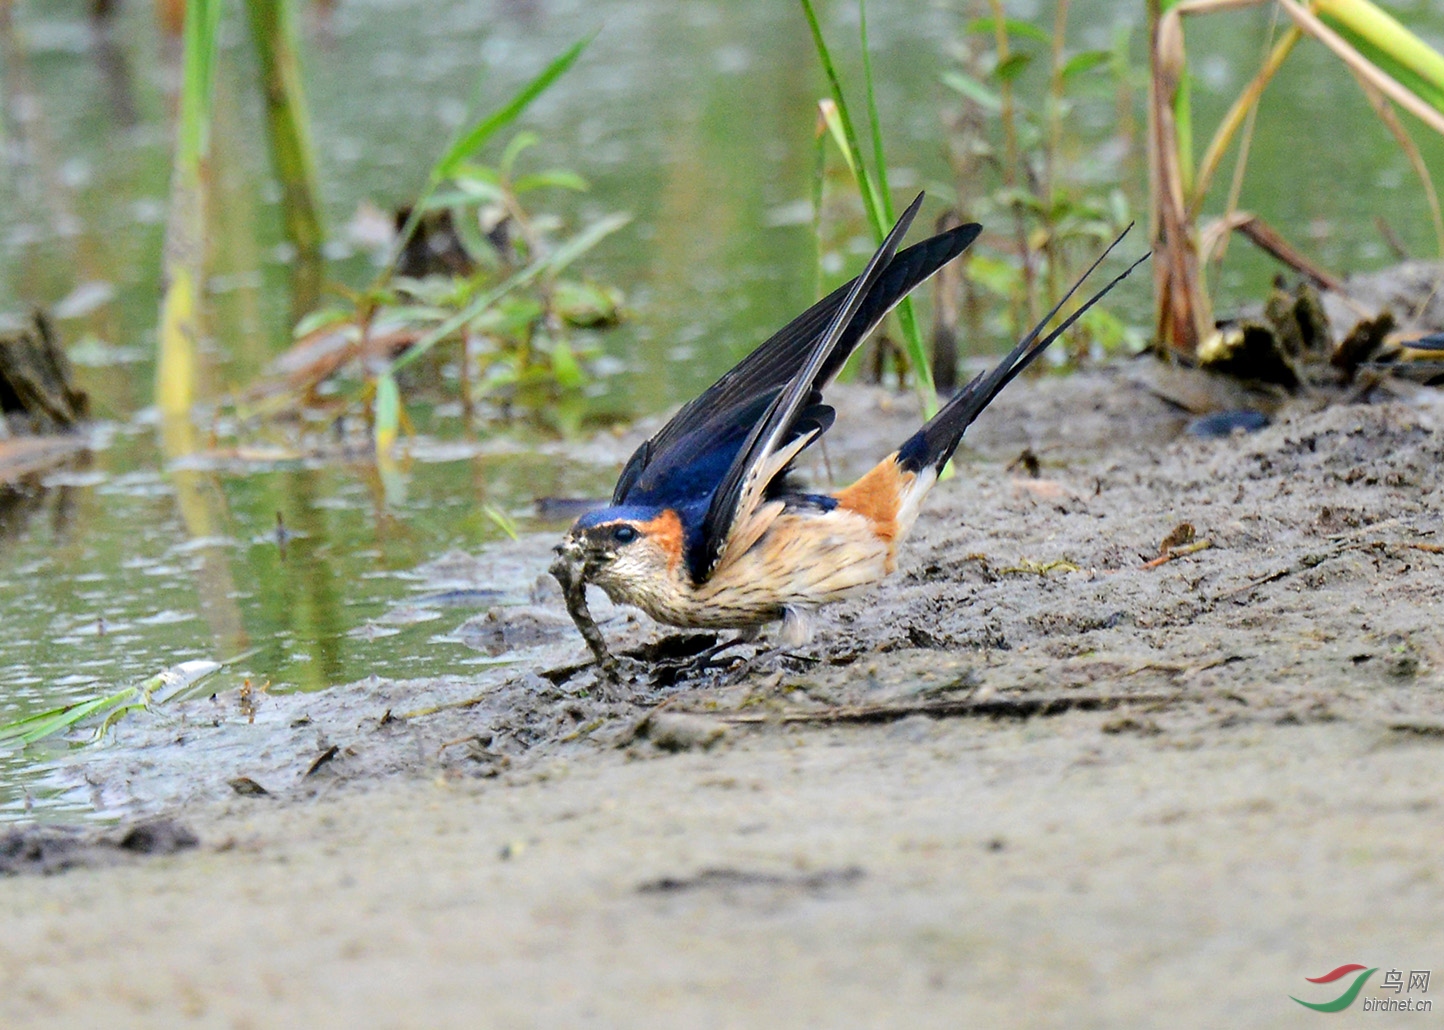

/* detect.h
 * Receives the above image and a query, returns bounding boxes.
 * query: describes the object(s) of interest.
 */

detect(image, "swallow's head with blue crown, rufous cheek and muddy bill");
[556,506,683,600]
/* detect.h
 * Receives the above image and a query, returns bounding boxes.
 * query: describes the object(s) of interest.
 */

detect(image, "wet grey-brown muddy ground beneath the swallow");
[0,365,1444,1027]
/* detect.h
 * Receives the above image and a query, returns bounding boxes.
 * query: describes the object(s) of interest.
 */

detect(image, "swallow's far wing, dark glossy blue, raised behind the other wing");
[612,196,982,504]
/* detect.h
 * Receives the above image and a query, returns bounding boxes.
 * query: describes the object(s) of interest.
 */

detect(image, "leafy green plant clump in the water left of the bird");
[265,40,628,455]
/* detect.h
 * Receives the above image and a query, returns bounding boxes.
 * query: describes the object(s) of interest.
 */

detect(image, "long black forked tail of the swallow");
[897,225,1152,472]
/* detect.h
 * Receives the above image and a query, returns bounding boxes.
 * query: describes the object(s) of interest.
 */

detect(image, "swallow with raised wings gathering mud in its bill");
[552,194,1148,669]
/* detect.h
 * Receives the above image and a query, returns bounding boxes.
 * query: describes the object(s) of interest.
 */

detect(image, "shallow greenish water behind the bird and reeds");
[0,0,1444,819]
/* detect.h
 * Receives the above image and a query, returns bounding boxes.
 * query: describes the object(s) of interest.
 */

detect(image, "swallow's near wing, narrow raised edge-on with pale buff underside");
[699,194,923,579]
